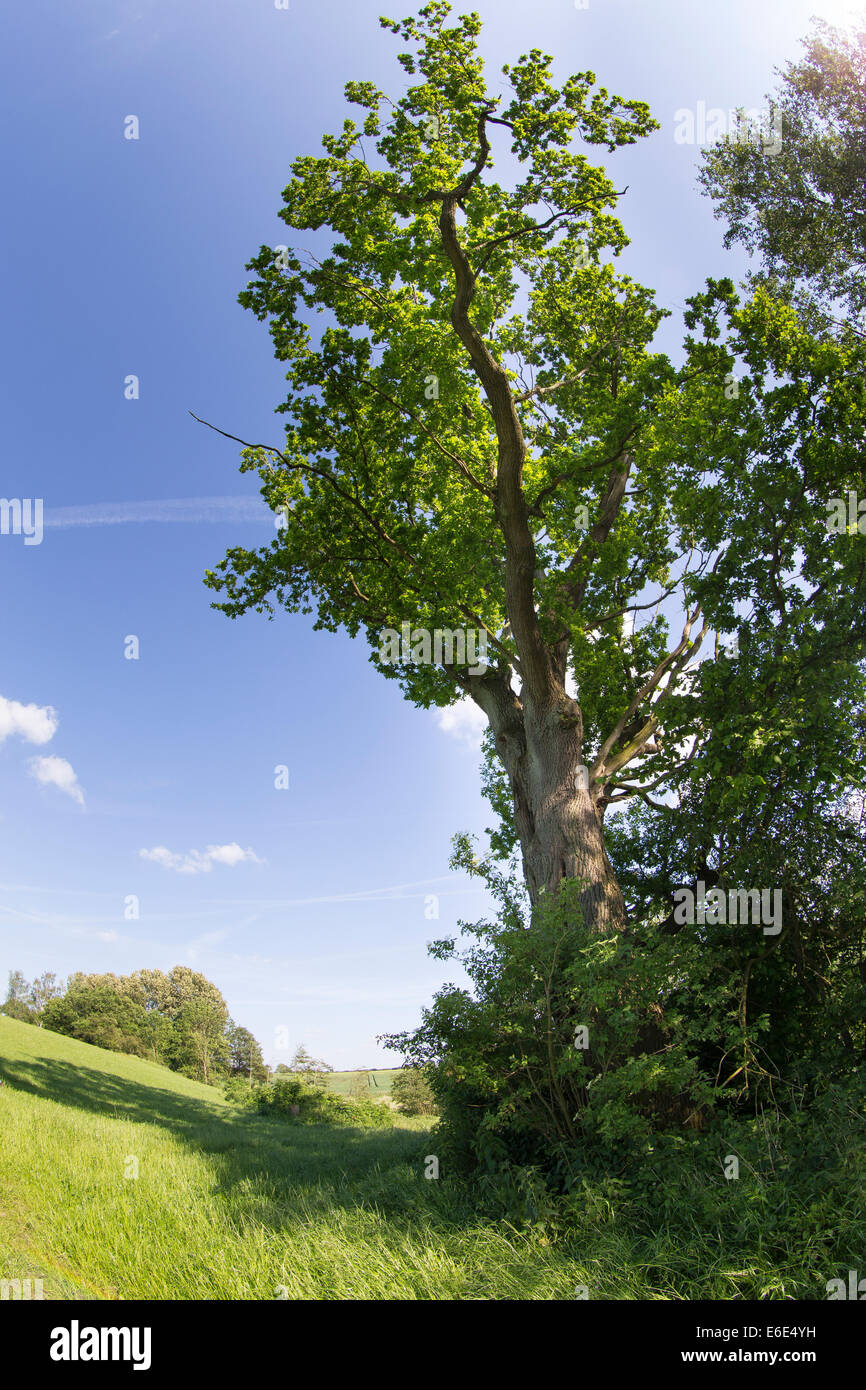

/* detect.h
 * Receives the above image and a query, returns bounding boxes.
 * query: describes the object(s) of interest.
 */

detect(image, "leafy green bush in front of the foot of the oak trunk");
[384,874,745,1186]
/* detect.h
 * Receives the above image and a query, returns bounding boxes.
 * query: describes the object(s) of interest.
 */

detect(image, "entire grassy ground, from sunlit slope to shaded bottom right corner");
[0,1016,866,1301]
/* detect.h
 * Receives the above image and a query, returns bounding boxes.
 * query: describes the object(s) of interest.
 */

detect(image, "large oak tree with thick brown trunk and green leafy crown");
[209,0,865,931]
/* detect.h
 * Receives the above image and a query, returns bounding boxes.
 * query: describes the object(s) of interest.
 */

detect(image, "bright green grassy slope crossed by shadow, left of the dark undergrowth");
[0,1016,581,1300]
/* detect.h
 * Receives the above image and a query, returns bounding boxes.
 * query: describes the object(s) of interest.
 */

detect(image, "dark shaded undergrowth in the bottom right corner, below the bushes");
[477,1070,866,1300]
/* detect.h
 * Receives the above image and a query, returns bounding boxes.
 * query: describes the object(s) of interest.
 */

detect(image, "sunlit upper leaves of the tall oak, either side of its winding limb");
[207,4,666,706]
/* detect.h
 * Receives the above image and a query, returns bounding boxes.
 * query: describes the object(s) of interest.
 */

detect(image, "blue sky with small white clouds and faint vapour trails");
[0,0,851,1068]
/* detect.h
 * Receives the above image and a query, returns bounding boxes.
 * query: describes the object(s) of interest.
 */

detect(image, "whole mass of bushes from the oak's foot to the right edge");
[391,811,866,1200]
